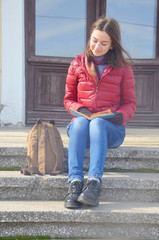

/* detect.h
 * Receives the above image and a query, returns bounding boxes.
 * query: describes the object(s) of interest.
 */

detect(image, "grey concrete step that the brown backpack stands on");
[0,171,159,202]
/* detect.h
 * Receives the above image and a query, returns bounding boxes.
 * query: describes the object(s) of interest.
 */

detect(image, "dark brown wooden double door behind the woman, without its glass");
[25,0,159,127]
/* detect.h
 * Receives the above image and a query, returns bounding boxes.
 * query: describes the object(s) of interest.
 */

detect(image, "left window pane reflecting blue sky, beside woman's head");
[36,0,86,57]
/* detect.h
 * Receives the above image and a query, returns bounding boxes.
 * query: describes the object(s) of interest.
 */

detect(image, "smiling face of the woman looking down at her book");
[90,30,112,57]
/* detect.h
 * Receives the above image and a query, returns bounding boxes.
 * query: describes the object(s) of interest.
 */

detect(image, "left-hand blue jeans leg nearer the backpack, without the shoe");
[68,117,89,182]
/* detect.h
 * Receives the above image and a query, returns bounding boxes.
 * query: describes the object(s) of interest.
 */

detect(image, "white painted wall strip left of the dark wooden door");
[0,0,25,127]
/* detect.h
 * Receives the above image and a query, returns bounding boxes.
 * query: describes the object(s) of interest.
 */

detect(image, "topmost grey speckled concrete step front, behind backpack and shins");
[0,146,159,170]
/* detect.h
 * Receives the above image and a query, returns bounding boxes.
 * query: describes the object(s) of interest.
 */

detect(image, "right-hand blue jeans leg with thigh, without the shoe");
[88,118,125,179]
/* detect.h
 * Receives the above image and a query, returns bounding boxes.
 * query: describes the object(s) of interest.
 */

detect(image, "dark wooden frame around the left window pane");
[25,0,105,63]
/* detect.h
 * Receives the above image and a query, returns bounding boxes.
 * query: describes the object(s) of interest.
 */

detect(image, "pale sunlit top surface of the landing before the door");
[0,127,159,147]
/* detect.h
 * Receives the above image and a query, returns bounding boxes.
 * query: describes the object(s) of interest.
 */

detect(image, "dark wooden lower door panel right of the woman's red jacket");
[128,60,159,127]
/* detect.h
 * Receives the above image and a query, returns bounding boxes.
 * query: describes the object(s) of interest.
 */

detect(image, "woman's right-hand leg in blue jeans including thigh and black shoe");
[78,118,125,206]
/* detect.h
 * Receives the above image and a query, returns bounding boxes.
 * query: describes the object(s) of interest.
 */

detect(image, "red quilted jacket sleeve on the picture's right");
[118,66,136,124]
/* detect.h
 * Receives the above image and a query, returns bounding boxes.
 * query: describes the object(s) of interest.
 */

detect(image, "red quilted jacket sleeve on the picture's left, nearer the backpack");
[64,59,83,115]
